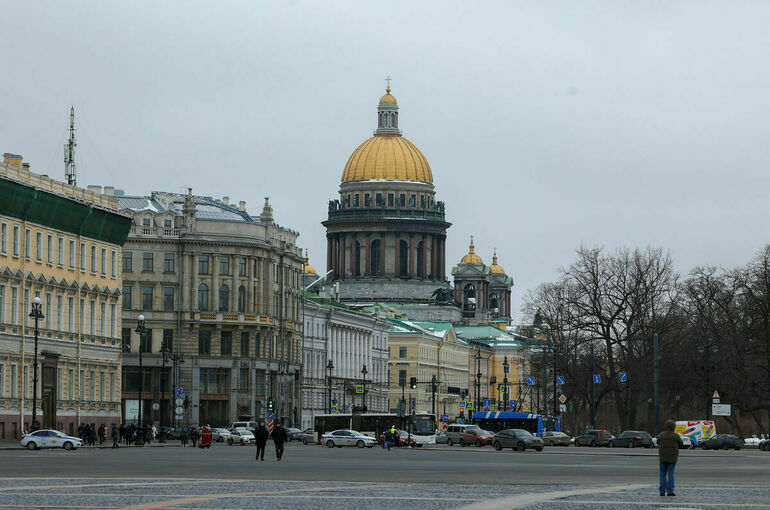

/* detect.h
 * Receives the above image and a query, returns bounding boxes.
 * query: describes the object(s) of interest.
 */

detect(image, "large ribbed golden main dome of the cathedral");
[342,135,433,183]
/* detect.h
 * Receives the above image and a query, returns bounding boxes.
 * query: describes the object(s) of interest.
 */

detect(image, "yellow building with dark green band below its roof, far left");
[0,154,131,439]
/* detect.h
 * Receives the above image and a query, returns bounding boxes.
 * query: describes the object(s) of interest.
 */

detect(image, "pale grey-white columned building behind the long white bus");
[302,272,389,428]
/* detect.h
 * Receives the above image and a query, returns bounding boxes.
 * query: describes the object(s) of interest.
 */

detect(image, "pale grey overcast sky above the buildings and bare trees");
[0,0,770,322]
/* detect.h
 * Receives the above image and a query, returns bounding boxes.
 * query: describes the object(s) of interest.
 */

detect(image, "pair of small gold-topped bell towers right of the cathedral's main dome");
[452,237,513,322]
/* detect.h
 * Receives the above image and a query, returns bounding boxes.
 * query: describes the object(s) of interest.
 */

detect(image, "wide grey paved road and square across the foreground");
[0,444,770,510]
